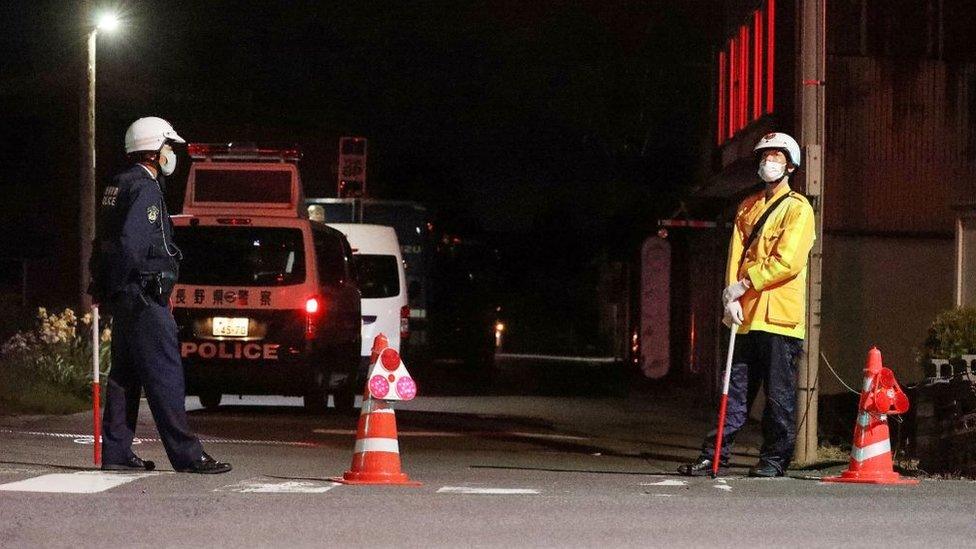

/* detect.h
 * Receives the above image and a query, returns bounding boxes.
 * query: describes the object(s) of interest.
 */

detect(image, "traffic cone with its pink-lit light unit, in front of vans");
[332,334,420,486]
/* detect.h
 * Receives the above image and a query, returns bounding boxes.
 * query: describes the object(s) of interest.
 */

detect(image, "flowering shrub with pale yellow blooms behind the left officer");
[0,308,112,400]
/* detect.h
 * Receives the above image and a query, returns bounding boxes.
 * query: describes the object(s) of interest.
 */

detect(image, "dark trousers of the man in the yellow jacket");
[701,331,803,471]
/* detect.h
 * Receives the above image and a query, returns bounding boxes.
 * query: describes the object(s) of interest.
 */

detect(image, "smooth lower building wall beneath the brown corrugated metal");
[820,234,955,394]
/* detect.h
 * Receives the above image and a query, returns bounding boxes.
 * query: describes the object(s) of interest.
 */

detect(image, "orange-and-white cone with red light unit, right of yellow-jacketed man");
[823,347,918,484]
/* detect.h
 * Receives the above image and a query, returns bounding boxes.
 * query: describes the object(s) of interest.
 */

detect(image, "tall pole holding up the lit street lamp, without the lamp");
[78,0,98,312]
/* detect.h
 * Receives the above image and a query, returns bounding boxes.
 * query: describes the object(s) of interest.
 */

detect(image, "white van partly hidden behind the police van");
[328,223,410,375]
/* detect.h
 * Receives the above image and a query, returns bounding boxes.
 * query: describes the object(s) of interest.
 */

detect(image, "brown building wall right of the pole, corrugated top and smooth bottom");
[820,55,976,393]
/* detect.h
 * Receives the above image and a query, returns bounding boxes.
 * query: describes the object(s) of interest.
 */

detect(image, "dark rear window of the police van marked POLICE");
[175,226,305,286]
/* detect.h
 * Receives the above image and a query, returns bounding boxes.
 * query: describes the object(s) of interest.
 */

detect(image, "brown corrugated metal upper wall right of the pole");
[824,56,976,235]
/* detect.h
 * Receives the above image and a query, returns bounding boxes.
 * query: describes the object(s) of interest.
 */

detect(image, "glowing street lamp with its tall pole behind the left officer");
[78,12,119,311]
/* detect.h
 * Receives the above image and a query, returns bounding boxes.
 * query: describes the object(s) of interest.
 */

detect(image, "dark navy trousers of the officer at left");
[102,288,203,469]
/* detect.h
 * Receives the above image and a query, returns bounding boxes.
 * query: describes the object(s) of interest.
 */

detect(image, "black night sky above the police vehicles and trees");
[0,0,717,324]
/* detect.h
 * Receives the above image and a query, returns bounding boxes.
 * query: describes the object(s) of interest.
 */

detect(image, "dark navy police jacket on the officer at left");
[89,164,181,302]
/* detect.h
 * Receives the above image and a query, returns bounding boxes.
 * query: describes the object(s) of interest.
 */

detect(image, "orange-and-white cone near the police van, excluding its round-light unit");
[332,334,420,486]
